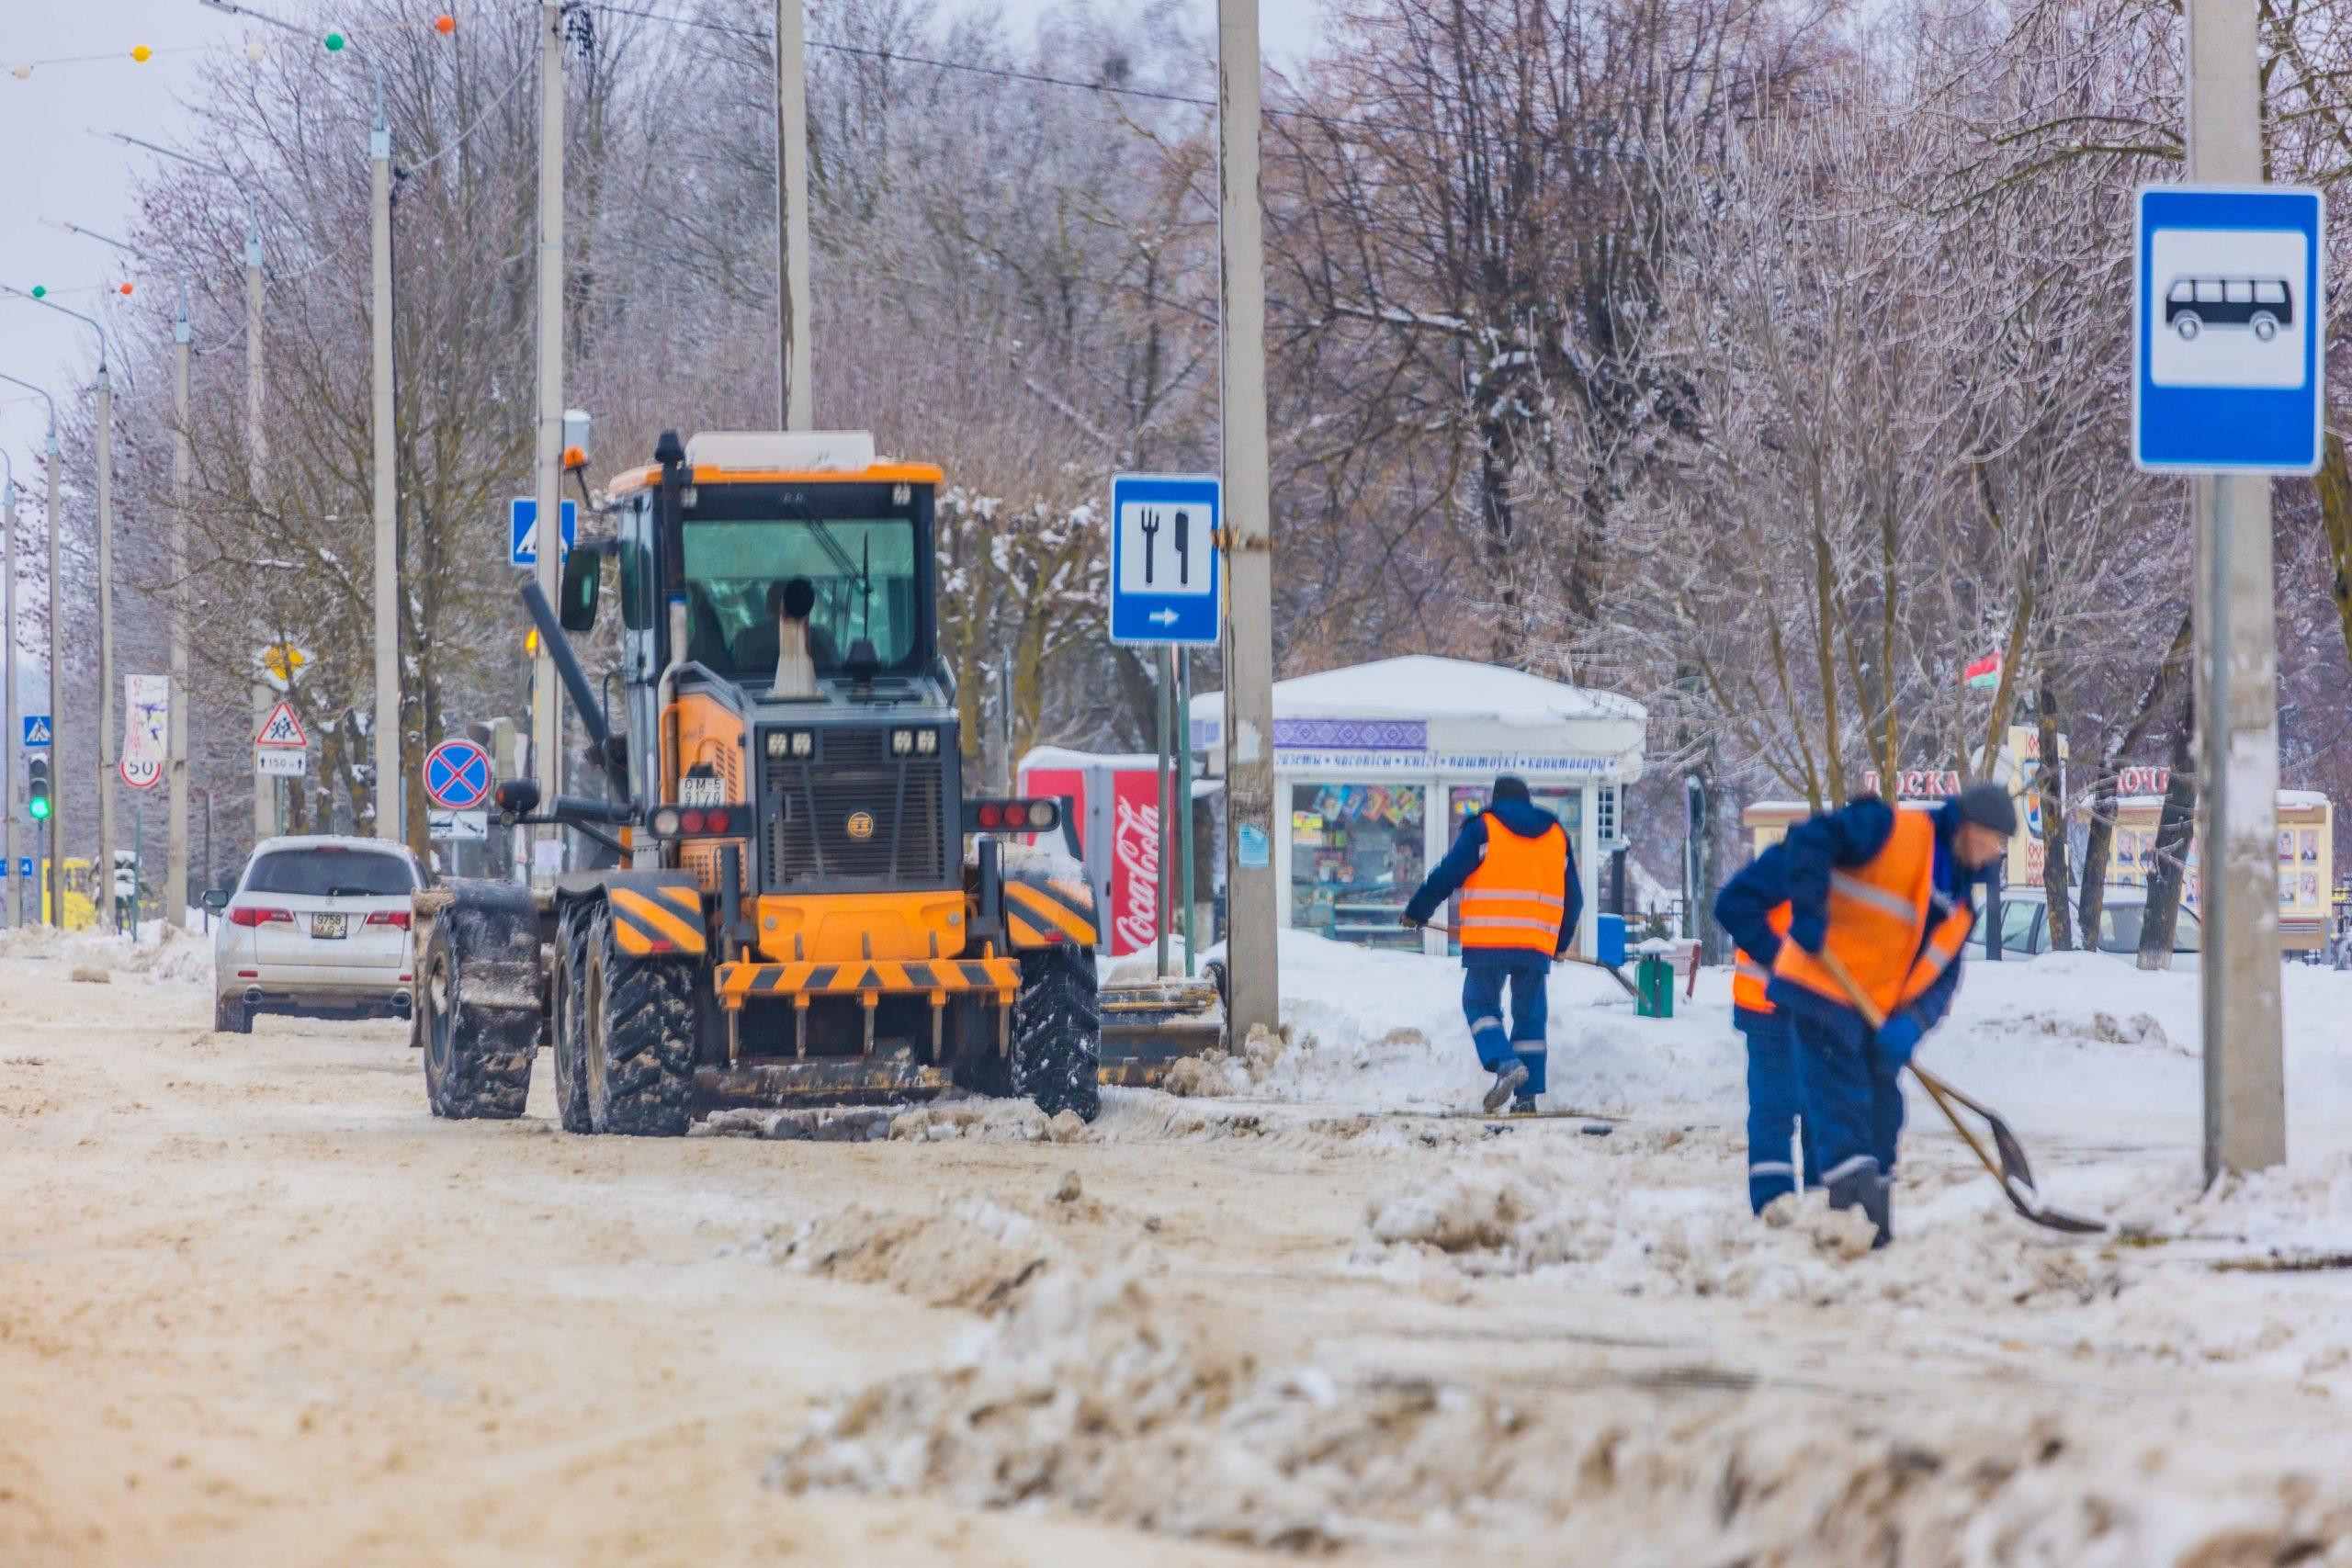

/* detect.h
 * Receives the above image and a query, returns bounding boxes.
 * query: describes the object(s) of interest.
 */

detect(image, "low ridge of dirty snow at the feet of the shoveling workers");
[1364,1152,2124,1309]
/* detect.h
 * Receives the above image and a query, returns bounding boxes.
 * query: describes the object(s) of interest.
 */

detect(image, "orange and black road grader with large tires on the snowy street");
[414,433,1216,1135]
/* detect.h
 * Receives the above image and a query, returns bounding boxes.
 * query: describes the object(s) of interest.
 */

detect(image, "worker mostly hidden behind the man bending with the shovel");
[1714,844,1820,1213]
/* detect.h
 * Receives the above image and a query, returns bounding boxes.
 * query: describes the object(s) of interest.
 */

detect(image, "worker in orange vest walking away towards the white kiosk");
[1402,773,1585,1112]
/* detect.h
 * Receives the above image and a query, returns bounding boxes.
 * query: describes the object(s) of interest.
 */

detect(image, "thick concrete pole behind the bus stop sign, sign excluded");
[2188,0,2286,1180]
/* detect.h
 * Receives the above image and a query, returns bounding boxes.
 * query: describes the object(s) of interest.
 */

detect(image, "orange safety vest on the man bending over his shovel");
[1771,807,1975,1013]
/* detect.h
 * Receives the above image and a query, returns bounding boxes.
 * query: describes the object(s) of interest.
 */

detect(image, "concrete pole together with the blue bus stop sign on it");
[2131,15,2326,1180]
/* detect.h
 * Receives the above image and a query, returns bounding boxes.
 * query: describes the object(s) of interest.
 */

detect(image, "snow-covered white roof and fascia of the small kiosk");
[1193,653,1649,783]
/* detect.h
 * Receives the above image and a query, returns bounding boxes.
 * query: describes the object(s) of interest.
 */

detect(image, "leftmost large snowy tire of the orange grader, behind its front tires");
[416,894,541,1122]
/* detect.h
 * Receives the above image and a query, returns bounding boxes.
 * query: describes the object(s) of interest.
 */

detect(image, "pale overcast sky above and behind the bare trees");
[0,0,1317,475]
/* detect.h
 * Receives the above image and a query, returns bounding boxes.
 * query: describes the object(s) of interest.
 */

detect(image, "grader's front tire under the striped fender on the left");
[581,903,701,1138]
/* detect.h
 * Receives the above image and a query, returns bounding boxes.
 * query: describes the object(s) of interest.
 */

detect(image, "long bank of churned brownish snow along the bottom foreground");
[764,1258,2352,1568]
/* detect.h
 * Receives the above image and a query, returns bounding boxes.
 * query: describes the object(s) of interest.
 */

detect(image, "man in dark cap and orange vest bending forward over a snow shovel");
[1764,783,2018,1246]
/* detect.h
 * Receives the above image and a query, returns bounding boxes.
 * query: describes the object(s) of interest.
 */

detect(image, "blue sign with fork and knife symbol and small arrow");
[1110,472,1226,647]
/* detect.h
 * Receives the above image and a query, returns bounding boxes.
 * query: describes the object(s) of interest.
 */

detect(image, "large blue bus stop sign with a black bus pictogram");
[2131,186,2326,472]
